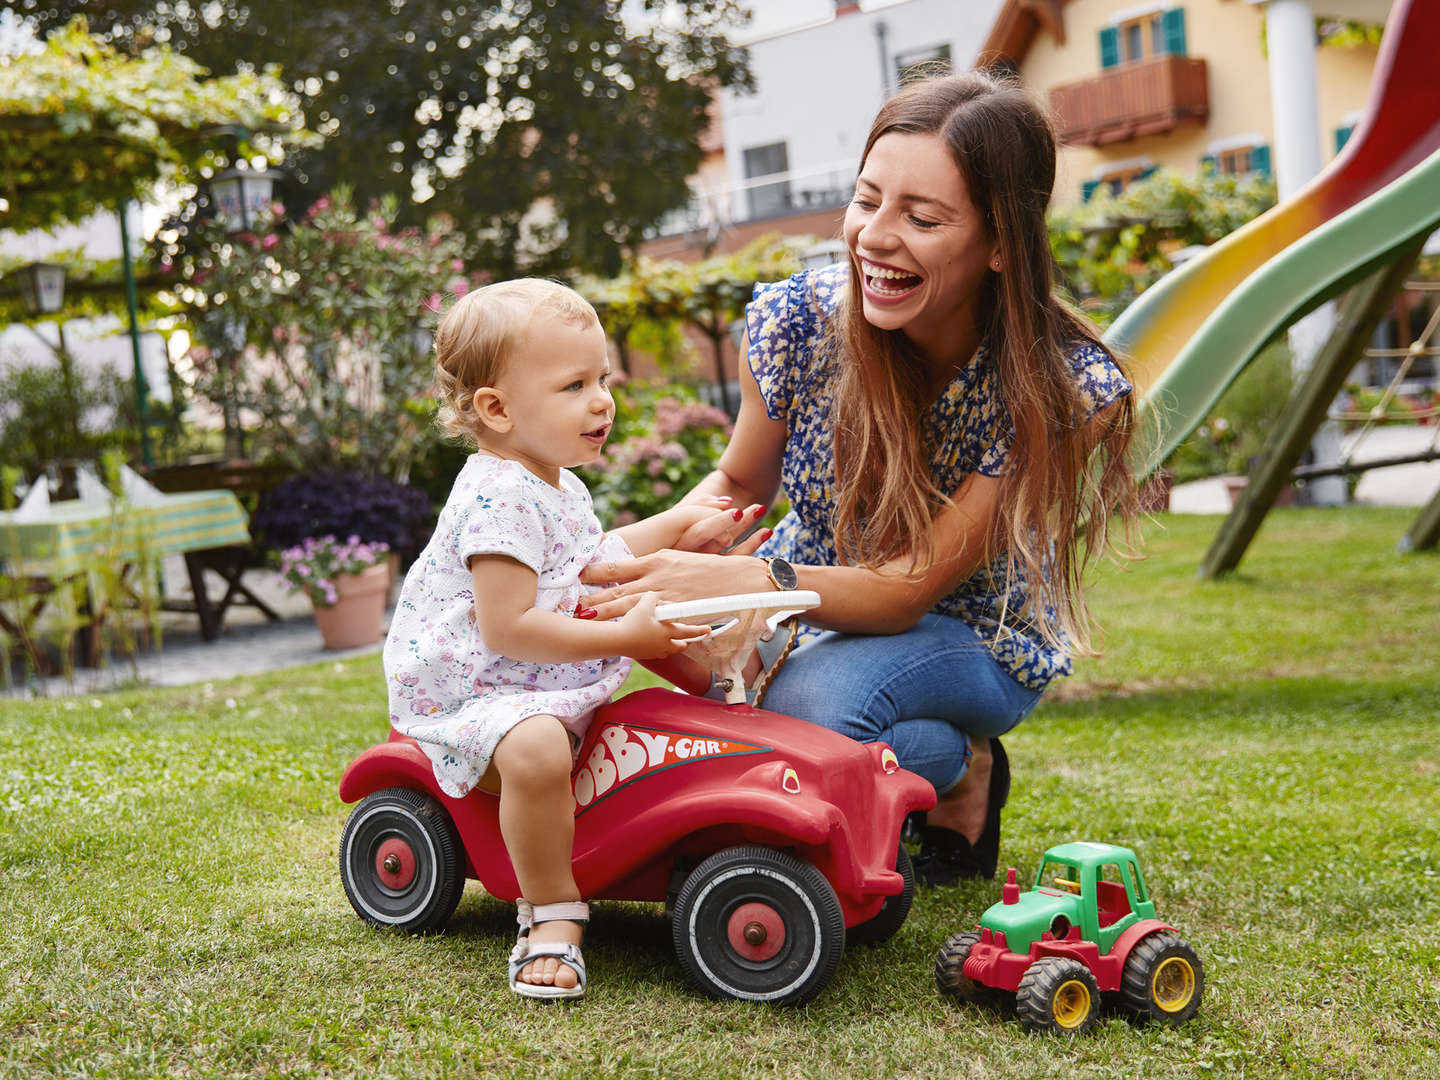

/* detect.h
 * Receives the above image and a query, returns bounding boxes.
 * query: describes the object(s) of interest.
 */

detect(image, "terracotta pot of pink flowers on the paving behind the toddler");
[279,534,390,649]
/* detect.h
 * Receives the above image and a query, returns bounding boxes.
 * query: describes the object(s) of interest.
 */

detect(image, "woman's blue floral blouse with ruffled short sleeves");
[746,265,1130,690]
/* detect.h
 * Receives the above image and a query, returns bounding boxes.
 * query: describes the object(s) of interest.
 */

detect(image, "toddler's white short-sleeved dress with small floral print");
[383,454,631,798]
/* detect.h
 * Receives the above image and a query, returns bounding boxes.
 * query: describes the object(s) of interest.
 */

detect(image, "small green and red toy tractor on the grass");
[935,841,1205,1035]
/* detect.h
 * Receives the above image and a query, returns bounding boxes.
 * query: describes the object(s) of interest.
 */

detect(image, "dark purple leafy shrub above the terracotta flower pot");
[251,472,435,557]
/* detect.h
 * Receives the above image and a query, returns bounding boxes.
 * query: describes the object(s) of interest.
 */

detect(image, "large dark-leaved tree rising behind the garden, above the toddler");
[22,0,747,276]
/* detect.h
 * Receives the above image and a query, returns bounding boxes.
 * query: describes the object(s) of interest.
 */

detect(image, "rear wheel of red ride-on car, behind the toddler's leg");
[340,788,465,933]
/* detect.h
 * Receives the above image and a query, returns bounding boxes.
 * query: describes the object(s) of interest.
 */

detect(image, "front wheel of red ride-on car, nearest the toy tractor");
[671,847,845,1005]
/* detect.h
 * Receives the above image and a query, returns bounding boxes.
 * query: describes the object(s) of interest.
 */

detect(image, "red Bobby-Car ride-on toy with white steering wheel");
[340,592,935,1004]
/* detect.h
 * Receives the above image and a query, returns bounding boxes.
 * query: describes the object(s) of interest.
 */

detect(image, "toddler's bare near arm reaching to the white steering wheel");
[469,554,710,664]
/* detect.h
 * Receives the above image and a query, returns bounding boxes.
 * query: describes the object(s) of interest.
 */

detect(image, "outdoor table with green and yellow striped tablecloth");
[0,491,279,659]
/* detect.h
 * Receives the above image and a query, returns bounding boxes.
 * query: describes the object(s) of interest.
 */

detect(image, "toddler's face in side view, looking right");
[495,318,615,482]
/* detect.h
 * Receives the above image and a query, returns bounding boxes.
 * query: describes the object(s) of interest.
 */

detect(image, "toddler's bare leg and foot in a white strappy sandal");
[482,716,582,986]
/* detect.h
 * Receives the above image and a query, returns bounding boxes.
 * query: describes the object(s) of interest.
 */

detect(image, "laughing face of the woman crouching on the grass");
[845,131,998,360]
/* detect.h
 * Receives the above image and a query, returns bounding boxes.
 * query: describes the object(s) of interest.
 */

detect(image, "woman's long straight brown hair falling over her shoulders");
[829,72,1138,651]
